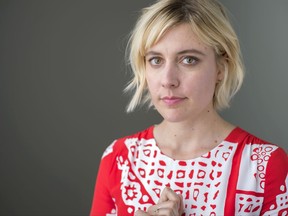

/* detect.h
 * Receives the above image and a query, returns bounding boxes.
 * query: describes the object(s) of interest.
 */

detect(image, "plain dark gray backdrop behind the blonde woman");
[0,0,288,216]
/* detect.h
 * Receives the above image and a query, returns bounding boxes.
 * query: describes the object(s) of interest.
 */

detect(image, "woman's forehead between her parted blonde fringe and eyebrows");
[146,23,213,53]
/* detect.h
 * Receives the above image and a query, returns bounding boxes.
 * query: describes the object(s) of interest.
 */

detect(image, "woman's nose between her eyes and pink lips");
[161,65,180,88]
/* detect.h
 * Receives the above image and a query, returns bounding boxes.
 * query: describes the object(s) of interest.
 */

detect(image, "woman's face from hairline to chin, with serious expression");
[145,24,222,122]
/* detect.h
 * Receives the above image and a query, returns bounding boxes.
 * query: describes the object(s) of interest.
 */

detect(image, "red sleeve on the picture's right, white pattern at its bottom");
[261,148,288,215]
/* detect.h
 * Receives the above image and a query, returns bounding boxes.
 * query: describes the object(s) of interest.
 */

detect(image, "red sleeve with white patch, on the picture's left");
[90,144,116,216]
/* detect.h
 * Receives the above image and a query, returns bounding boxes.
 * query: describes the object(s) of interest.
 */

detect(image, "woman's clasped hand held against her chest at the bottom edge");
[135,187,184,216]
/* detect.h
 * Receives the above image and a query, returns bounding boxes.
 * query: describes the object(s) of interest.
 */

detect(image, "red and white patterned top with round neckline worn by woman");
[90,126,288,216]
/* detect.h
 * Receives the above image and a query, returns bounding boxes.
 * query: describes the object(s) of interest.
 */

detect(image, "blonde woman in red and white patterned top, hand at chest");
[91,0,288,216]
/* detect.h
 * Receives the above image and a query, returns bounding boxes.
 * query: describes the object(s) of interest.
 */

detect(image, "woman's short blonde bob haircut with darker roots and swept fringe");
[124,0,244,112]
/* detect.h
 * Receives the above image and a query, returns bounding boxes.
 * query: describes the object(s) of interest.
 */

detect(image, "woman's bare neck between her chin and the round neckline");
[154,111,234,159]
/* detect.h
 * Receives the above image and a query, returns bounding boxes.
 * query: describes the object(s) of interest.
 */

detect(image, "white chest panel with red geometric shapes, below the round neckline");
[118,138,237,215]
